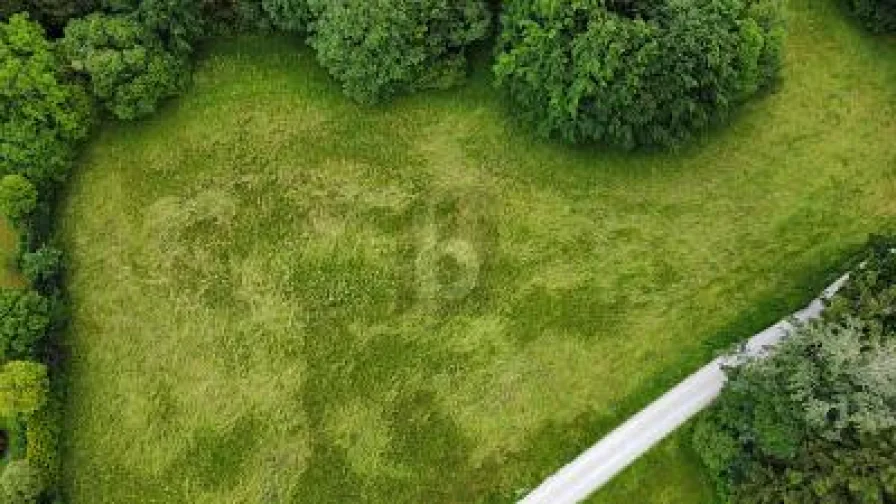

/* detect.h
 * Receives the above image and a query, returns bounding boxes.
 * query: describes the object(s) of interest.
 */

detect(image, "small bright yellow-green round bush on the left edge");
[0,361,50,416]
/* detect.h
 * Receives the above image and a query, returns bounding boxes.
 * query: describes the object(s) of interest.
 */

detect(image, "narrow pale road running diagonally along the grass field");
[520,275,848,504]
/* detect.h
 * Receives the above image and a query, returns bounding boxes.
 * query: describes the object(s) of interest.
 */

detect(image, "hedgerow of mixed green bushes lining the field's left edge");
[0,13,94,503]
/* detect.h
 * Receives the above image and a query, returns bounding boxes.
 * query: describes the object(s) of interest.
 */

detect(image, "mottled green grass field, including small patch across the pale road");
[62,0,896,504]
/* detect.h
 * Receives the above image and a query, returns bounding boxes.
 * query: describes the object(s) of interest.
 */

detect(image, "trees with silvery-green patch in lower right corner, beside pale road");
[694,240,896,504]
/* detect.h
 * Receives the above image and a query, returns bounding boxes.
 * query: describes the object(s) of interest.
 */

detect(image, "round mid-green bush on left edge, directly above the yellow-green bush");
[0,289,52,360]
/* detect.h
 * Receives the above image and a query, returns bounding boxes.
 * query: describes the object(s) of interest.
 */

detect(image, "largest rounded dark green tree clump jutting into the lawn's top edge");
[495,0,783,148]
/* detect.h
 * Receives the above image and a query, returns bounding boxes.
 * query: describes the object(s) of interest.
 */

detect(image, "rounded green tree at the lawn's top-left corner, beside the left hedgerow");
[62,14,187,119]
